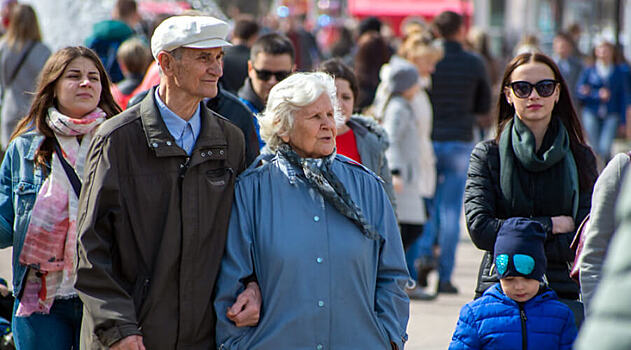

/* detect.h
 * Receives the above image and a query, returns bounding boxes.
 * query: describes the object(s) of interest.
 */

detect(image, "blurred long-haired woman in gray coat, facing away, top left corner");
[0,4,50,149]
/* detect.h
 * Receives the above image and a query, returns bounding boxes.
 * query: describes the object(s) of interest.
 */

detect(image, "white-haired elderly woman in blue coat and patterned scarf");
[215,73,409,350]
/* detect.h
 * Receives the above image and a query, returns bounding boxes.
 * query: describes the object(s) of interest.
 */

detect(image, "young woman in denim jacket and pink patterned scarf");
[0,47,120,349]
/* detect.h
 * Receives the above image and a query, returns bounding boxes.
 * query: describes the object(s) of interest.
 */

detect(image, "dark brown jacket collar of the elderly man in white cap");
[140,87,228,159]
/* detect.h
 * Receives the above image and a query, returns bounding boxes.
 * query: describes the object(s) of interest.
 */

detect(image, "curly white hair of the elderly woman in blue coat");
[257,72,344,152]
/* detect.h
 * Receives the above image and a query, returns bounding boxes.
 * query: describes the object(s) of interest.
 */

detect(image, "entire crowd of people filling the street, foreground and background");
[0,0,631,350]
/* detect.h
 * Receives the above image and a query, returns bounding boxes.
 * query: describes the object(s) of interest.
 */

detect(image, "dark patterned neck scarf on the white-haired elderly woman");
[278,143,380,240]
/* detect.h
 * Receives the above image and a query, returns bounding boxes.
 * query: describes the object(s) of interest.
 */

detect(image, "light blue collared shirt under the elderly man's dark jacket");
[155,88,202,156]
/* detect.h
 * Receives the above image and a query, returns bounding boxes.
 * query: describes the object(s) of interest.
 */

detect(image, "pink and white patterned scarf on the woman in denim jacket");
[16,107,105,316]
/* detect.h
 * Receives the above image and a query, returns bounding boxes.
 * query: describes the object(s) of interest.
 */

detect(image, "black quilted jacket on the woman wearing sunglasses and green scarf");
[464,140,596,299]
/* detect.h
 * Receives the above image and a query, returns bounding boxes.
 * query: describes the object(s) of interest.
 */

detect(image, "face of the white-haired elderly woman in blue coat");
[281,93,337,158]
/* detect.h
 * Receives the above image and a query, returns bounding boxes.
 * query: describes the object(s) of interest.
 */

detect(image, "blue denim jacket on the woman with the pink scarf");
[0,131,46,296]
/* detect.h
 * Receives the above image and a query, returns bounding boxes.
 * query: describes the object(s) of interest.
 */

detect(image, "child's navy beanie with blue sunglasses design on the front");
[493,218,547,281]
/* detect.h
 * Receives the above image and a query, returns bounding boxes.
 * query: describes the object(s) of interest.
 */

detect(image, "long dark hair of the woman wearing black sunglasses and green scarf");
[495,52,598,188]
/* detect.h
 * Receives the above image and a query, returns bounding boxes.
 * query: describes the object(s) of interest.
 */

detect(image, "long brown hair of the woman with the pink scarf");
[11,46,121,165]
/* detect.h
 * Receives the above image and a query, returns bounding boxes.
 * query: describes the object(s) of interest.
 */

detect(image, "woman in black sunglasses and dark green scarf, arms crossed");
[464,53,598,308]
